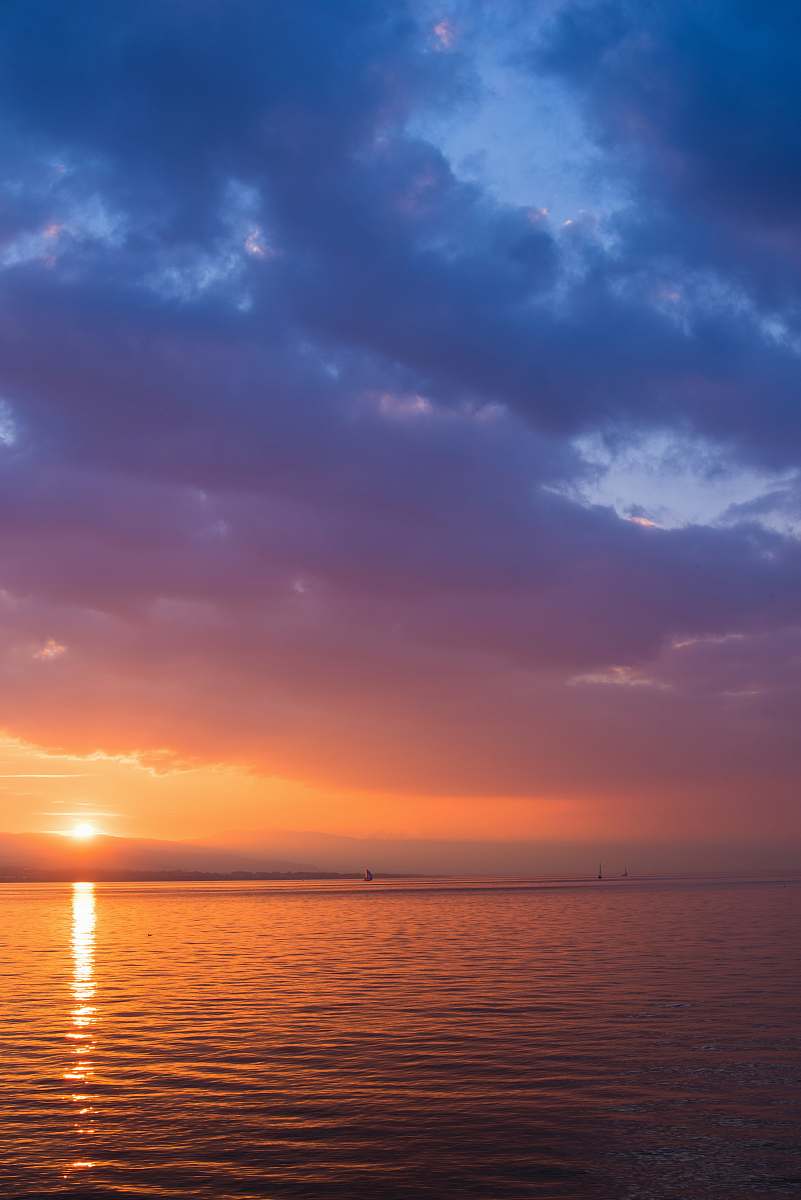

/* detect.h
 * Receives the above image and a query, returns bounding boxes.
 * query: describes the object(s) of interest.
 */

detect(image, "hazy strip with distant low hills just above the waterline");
[0,830,801,880]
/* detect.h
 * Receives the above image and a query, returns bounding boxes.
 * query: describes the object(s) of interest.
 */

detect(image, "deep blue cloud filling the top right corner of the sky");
[531,0,801,305]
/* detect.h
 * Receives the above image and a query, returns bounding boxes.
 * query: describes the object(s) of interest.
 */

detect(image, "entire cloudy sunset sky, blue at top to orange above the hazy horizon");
[0,0,801,869]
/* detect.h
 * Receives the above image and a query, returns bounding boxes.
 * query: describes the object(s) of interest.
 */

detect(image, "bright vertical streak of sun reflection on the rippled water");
[64,883,97,1170]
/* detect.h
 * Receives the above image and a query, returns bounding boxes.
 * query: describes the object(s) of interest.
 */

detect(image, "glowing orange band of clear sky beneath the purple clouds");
[0,737,796,847]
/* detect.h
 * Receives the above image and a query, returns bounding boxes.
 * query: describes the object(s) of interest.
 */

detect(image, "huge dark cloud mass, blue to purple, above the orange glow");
[0,0,801,825]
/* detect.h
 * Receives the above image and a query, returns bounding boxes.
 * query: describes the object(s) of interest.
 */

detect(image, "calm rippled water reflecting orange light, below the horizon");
[0,881,801,1200]
